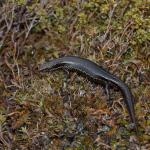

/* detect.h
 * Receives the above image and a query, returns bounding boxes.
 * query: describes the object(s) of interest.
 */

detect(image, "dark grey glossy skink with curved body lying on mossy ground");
[39,56,137,130]
